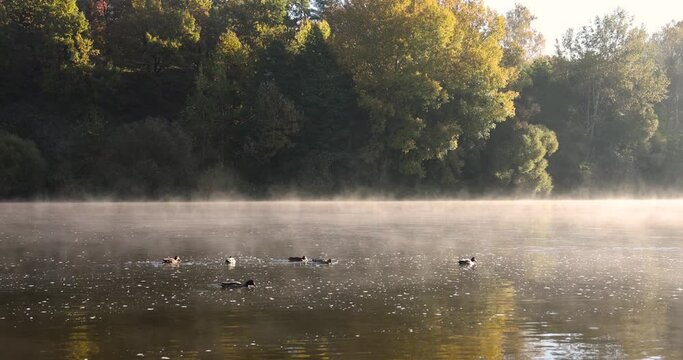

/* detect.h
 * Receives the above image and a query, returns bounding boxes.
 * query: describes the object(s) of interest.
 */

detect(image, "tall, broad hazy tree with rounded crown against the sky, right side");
[544,10,667,185]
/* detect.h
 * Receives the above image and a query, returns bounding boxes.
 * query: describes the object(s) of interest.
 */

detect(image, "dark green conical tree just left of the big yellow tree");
[277,20,360,194]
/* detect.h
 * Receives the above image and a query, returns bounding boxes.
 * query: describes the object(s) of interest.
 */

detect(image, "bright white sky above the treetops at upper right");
[484,0,683,54]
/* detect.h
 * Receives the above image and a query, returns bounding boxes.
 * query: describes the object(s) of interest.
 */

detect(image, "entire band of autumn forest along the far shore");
[0,0,683,199]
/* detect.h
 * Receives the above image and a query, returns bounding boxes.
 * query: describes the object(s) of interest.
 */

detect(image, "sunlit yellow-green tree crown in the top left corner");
[0,0,95,97]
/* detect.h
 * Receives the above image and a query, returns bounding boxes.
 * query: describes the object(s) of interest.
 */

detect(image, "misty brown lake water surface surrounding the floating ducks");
[0,201,683,359]
